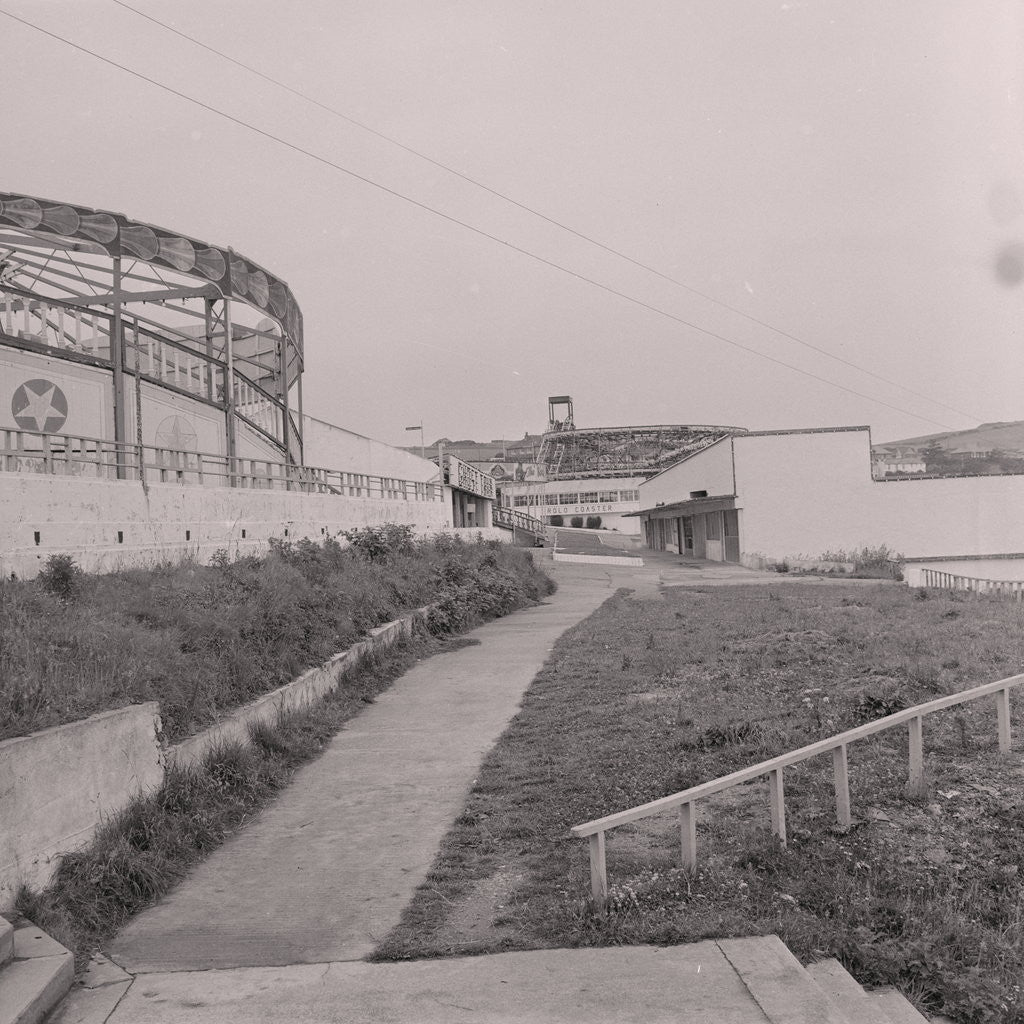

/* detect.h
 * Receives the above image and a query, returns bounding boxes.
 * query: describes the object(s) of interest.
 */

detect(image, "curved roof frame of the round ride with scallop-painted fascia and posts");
[0,191,304,464]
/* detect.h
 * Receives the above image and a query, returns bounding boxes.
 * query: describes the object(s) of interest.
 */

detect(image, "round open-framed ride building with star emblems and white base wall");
[0,193,499,575]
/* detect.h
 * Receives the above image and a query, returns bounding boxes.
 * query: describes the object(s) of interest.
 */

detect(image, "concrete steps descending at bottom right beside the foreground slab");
[718,935,951,1024]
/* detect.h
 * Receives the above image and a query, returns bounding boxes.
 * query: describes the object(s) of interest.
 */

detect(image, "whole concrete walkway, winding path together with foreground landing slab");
[14,552,937,1024]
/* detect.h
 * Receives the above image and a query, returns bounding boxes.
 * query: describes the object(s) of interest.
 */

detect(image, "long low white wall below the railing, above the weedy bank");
[0,472,452,578]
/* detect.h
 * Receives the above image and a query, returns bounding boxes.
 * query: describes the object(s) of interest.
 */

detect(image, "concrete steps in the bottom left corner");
[0,918,75,1024]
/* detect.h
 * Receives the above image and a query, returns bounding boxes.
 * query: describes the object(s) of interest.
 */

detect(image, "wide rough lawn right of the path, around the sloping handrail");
[376,583,1024,1024]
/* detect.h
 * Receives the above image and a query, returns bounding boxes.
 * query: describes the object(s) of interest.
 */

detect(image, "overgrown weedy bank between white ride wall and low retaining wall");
[0,524,552,740]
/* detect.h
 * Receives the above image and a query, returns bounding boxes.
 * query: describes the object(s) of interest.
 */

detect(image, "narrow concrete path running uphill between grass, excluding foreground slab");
[110,571,610,974]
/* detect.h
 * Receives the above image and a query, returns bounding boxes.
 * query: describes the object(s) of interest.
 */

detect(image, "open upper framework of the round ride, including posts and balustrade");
[0,193,303,468]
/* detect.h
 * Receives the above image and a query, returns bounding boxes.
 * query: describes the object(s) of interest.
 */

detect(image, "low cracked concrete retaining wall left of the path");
[0,608,428,913]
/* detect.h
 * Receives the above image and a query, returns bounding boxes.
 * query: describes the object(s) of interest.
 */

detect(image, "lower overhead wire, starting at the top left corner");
[0,7,963,430]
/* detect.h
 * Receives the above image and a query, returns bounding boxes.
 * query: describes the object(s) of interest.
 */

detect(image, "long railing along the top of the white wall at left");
[0,428,444,502]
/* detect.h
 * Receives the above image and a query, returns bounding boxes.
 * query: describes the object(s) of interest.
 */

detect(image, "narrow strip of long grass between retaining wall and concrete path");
[16,631,479,965]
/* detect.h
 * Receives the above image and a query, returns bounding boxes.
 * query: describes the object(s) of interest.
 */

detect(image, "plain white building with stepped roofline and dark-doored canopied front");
[636,427,1024,568]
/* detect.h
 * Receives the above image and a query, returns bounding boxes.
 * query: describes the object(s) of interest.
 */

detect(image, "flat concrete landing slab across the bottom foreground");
[99,942,770,1024]
